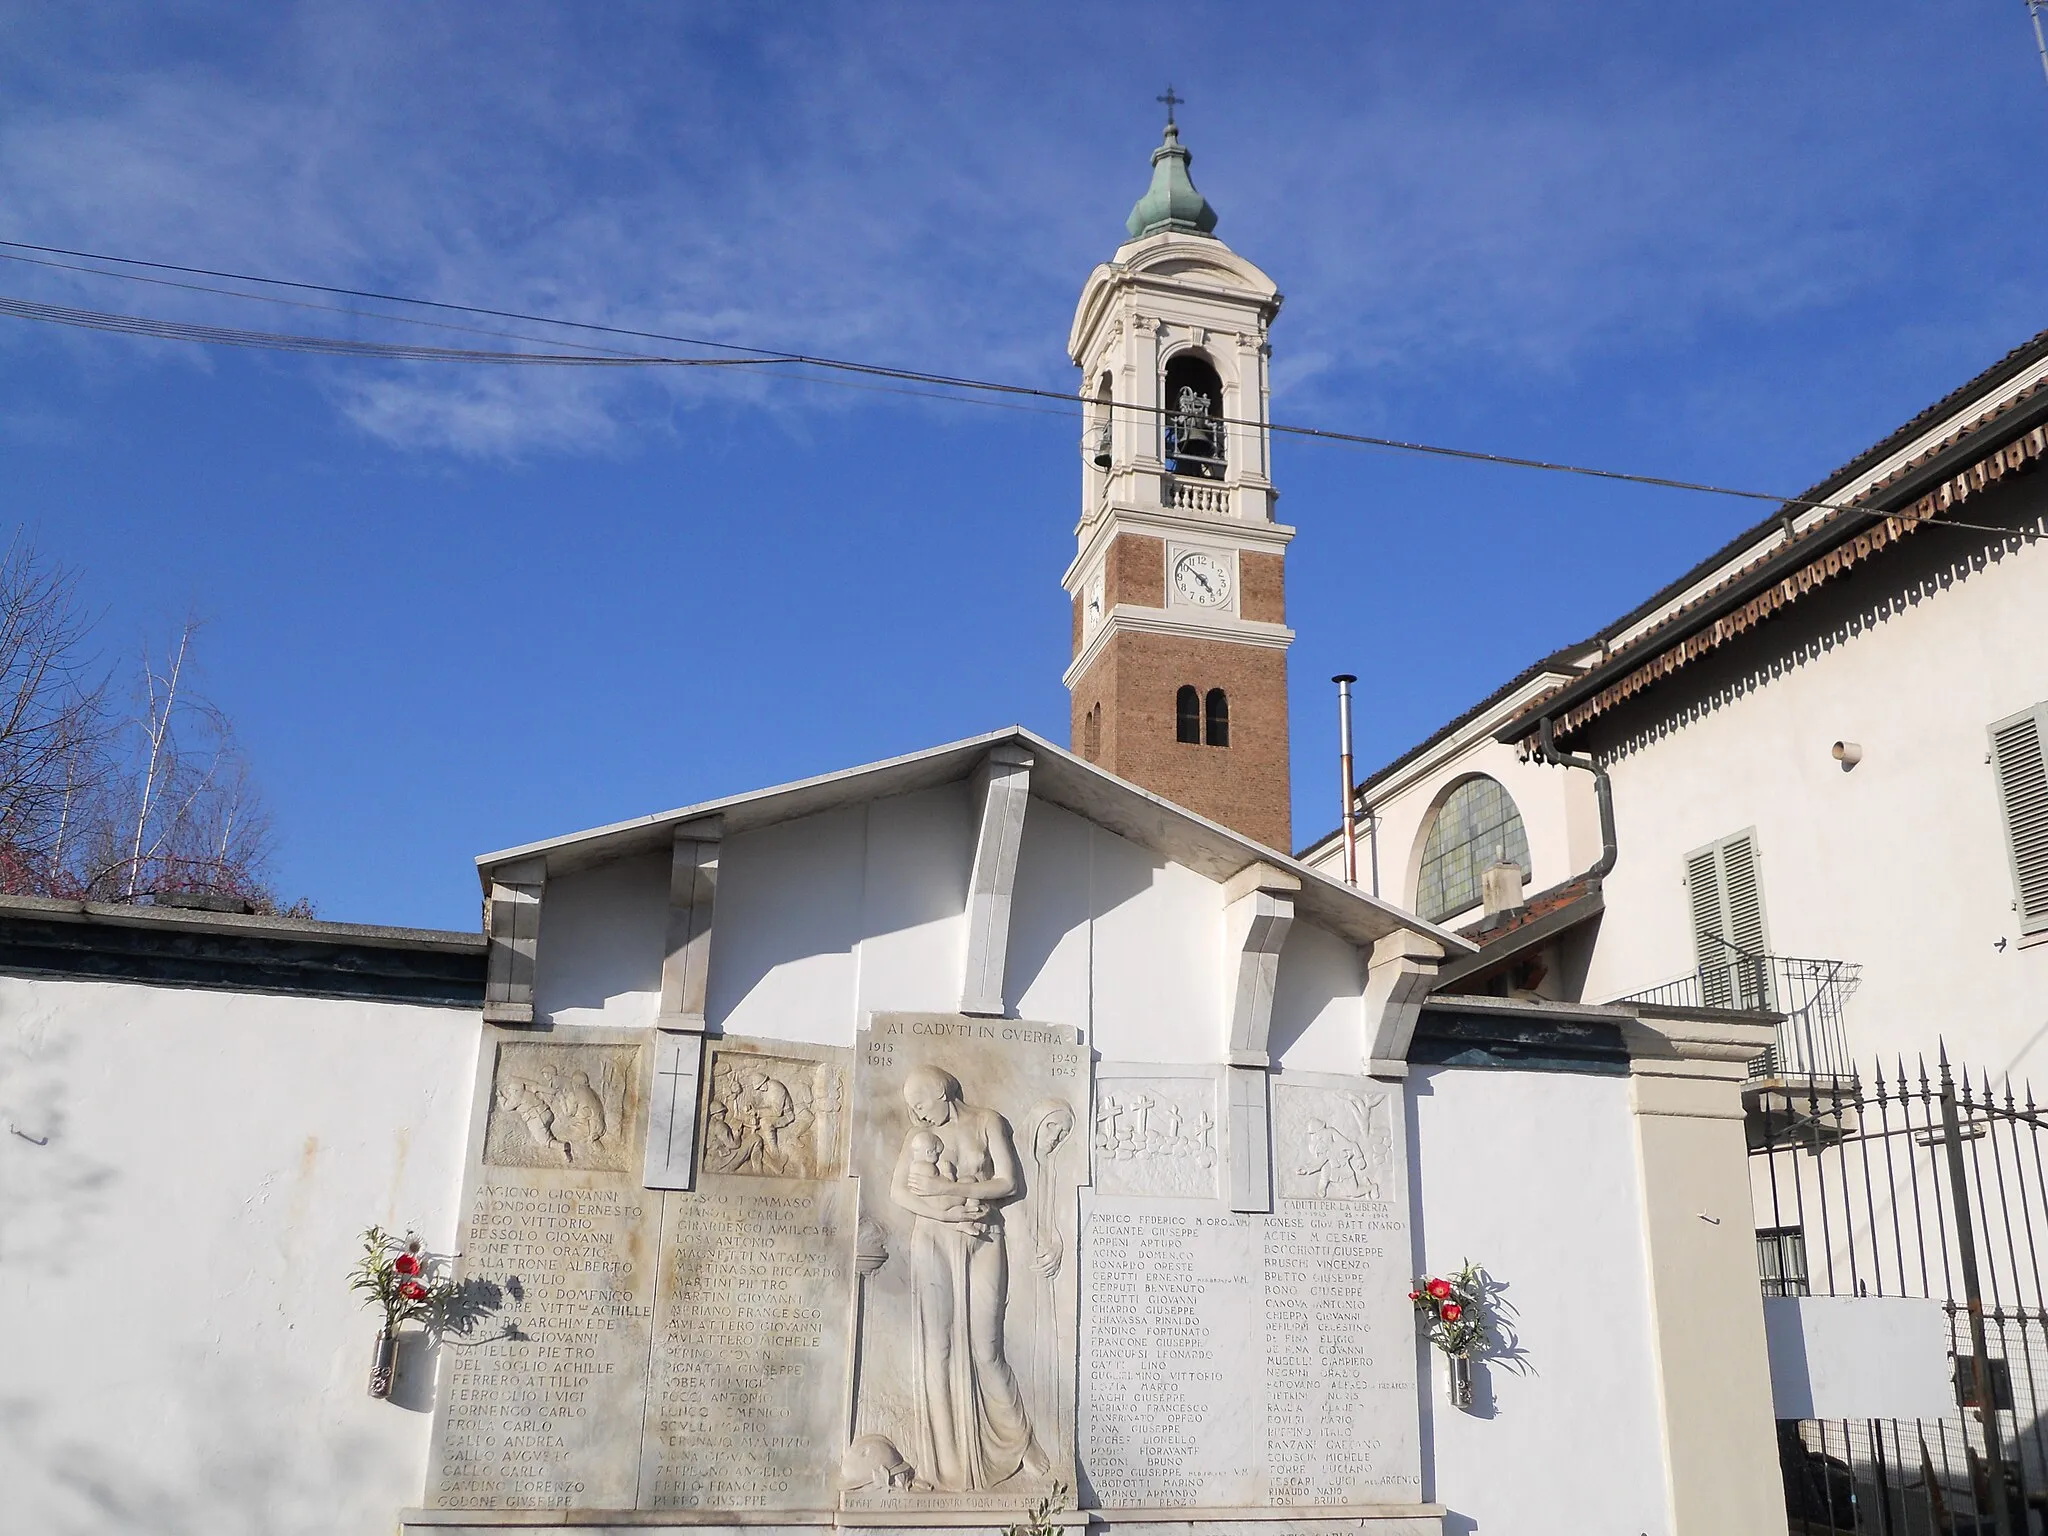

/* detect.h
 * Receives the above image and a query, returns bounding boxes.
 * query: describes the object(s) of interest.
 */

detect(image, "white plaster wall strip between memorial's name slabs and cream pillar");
[1409,1067,1671,1536]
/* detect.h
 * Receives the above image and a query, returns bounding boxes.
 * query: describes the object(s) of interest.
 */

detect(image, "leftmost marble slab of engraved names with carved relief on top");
[426,1030,657,1509]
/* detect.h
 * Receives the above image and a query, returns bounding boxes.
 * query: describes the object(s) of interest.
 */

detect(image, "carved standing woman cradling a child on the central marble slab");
[889,1067,1051,1493]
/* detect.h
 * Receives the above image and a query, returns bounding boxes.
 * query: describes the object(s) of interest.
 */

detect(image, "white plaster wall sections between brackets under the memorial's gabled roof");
[535,782,1327,1071]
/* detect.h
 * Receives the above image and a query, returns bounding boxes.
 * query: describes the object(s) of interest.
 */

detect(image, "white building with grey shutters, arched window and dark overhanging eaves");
[1303,334,2048,1085]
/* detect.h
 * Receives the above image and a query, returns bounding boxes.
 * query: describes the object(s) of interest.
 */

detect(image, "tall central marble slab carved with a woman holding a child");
[842,1014,1087,1520]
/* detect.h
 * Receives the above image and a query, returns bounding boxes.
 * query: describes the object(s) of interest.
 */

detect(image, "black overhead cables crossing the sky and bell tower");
[0,234,2048,539]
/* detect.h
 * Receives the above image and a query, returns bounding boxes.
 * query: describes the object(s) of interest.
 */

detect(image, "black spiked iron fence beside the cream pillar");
[1747,1057,2048,1536]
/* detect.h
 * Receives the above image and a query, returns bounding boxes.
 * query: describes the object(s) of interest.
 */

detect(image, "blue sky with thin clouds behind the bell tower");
[0,0,2048,928]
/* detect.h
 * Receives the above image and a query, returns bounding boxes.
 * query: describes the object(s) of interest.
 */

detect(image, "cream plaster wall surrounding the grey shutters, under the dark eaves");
[1587,530,2048,1071]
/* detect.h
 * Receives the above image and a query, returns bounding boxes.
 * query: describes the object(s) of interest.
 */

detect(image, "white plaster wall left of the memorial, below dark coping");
[0,979,481,1536]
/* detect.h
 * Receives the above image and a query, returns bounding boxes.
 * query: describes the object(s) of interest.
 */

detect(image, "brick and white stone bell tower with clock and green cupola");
[1065,108,1294,852]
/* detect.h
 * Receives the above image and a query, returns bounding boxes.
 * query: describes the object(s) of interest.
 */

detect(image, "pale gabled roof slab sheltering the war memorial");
[477,725,1475,954]
